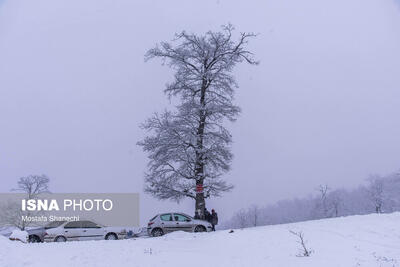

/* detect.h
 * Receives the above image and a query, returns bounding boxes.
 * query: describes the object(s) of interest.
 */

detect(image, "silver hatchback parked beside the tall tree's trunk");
[147,212,212,236]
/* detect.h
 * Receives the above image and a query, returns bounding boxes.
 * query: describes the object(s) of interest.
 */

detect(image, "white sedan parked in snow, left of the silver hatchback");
[44,221,126,242]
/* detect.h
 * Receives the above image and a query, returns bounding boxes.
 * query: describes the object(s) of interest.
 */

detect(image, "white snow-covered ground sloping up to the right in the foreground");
[0,213,400,267]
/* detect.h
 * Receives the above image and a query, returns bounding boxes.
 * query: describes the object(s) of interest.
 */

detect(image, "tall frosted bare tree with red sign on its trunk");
[138,25,258,217]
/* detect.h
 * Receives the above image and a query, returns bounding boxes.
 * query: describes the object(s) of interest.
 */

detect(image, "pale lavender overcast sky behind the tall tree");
[0,0,400,226]
